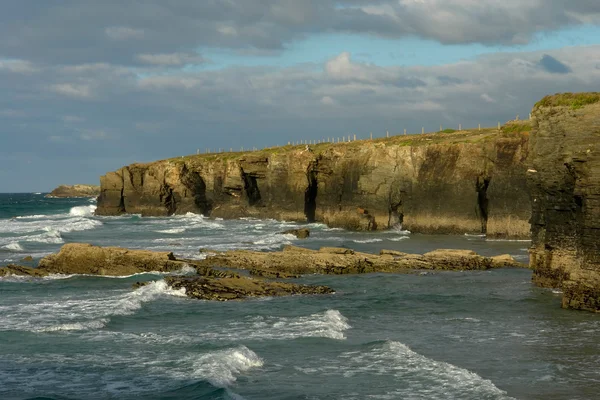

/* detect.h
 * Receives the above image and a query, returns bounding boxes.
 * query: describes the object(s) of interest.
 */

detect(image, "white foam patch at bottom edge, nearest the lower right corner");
[298,341,511,400]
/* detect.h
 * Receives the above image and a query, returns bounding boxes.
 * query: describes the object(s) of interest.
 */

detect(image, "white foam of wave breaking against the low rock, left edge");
[0,276,185,332]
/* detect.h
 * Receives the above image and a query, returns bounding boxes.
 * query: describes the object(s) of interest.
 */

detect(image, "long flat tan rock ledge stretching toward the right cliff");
[197,246,527,278]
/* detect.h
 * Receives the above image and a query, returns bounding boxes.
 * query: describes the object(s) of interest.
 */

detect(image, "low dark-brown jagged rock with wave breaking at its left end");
[165,276,334,301]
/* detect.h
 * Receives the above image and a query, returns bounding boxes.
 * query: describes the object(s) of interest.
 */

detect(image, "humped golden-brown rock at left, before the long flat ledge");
[38,243,188,276]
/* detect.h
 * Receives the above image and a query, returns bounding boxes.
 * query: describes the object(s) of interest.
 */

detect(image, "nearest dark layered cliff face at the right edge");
[528,95,600,311]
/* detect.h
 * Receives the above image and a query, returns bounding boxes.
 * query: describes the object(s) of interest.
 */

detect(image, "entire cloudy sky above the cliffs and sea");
[0,0,600,192]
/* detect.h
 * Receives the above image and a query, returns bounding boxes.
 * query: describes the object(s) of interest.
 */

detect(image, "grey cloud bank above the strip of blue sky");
[0,0,600,65]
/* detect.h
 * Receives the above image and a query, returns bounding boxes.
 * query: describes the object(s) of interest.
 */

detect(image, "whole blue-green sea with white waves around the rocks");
[0,194,600,400]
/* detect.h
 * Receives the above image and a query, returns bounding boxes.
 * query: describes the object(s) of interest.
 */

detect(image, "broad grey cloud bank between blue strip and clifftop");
[0,41,600,190]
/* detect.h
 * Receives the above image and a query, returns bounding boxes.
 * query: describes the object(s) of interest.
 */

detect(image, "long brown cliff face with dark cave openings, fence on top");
[96,130,531,236]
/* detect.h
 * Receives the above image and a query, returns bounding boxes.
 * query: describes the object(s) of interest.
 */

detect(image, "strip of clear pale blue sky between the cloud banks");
[199,24,600,69]
